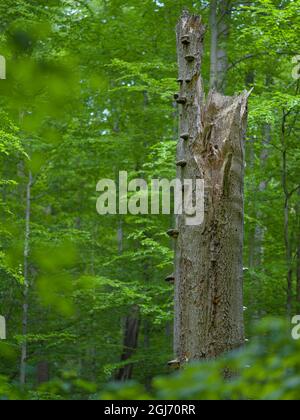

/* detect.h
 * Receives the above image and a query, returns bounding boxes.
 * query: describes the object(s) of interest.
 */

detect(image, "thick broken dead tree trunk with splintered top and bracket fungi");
[174,13,248,364]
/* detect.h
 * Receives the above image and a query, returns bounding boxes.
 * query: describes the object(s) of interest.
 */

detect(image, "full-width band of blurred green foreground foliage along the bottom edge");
[0,318,300,400]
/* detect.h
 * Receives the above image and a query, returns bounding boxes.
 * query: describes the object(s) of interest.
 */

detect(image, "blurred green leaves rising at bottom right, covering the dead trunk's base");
[102,318,300,400]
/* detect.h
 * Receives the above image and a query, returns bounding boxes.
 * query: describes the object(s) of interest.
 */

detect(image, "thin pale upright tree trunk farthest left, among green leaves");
[20,172,32,387]
